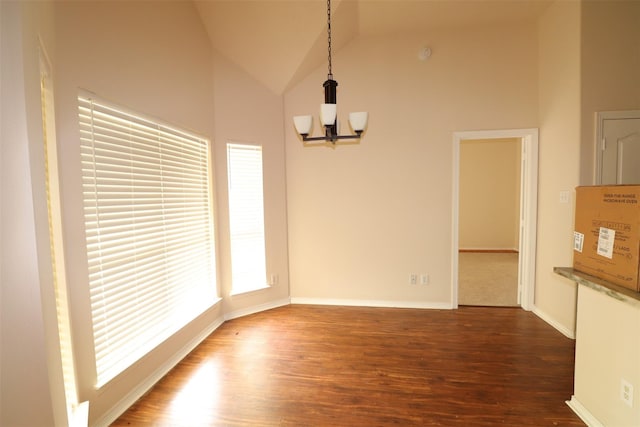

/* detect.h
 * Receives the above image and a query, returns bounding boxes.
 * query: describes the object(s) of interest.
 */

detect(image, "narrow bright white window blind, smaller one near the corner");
[227,143,267,294]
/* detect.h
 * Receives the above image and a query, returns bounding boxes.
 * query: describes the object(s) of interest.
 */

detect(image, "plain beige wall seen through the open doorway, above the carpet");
[459,138,521,250]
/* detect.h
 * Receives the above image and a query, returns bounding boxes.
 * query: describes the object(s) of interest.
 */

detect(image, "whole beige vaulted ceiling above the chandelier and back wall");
[195,0,552,94]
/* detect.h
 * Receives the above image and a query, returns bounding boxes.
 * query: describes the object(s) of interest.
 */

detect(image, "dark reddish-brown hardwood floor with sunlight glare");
[113,305,584,427]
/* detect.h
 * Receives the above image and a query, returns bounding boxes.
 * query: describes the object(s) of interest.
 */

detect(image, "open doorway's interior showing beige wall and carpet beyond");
[458,138,522,307]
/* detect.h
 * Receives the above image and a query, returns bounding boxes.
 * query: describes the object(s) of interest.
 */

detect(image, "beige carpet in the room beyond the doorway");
[458,252,518,307]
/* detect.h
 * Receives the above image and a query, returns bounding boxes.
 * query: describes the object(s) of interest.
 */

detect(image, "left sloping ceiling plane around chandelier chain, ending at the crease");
[194,0,358,95]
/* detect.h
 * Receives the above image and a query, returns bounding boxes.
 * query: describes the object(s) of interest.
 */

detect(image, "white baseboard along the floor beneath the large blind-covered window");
[94,314,225,427]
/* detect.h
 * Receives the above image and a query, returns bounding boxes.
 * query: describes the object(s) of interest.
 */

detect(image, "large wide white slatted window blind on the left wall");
[78,95,217,387]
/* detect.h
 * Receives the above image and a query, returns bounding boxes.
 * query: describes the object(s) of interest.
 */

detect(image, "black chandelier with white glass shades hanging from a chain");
[293,0,369,145]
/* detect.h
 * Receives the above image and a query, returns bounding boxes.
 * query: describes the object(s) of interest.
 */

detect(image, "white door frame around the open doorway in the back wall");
[451,128,538,311]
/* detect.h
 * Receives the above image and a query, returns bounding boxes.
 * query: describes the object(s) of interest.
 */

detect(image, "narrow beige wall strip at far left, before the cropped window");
[0,2,66,426]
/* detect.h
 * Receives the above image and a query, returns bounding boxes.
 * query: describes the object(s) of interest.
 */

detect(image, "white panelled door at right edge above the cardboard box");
[598,116,640,185]
